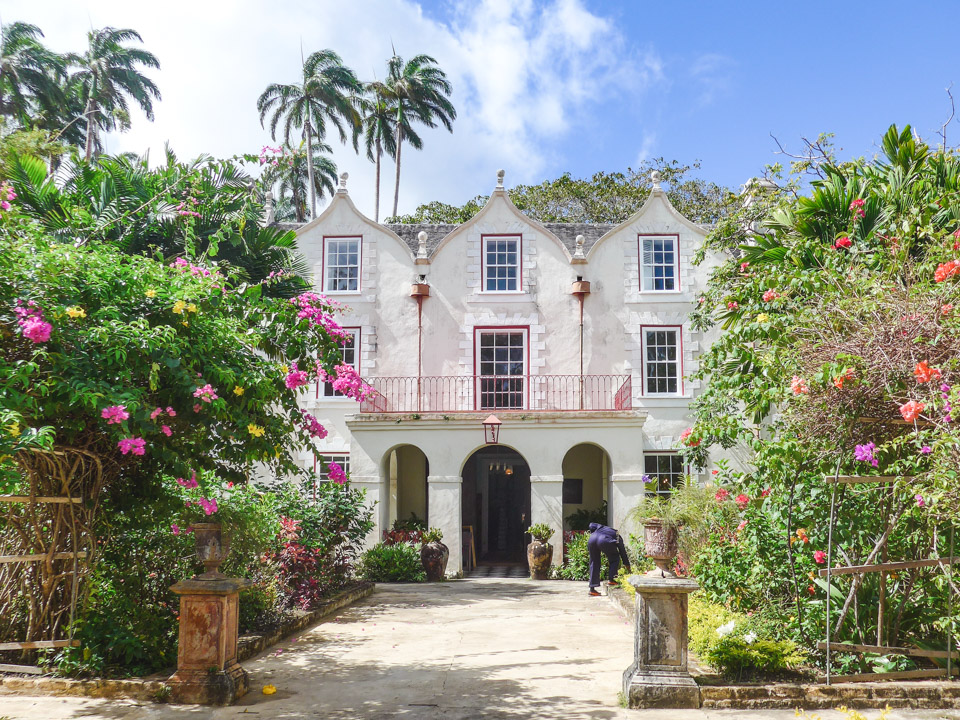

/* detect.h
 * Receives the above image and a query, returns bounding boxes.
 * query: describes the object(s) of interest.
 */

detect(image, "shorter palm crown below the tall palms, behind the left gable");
[263,141,337,223]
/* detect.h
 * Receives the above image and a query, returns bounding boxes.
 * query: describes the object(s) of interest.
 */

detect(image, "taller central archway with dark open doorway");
[460,445,530,569]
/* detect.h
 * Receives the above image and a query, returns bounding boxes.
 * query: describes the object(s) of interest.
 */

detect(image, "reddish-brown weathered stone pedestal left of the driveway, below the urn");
[167,577,252,705]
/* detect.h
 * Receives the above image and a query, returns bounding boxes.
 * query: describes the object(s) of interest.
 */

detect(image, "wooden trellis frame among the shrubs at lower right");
[817,470,960,685]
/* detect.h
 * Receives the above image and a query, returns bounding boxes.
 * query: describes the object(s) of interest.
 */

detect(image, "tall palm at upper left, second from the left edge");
[68,27,160,162]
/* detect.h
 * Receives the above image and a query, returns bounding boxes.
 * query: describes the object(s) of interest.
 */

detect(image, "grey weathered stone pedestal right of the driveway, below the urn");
[623,571,700,708]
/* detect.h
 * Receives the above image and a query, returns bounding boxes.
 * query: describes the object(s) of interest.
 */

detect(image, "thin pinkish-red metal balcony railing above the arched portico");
[360,375,633,413]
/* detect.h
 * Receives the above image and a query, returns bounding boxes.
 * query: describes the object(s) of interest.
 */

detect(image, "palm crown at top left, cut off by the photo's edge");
[0,22,66,125]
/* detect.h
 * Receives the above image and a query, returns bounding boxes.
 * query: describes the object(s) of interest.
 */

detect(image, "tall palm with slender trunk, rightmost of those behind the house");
[386,54,457,217]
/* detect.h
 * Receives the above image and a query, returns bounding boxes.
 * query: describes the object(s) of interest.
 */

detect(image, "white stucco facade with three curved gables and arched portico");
[290,173,736,572]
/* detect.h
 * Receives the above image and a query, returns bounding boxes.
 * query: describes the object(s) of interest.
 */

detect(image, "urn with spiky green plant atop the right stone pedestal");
[631,478,712,577]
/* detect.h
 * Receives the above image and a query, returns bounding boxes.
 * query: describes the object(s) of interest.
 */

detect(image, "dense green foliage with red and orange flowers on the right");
[686,127,960,669]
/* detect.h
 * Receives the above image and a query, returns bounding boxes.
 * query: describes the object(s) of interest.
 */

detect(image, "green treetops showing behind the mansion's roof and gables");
[396,158,740,225]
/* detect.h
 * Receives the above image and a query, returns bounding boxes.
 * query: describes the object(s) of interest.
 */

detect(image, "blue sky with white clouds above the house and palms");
[3,0,960,213]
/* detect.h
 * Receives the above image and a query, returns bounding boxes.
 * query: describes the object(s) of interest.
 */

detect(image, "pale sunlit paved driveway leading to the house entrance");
[0,579,960,720]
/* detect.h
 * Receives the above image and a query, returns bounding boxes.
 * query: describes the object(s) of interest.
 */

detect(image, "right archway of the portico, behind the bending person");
[563,443,610,531]
